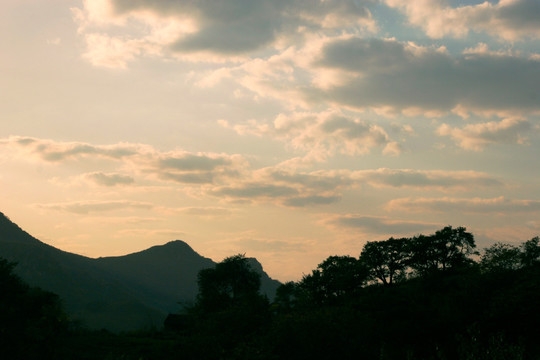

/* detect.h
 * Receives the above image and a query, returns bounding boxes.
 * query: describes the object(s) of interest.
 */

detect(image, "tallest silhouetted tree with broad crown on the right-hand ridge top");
[409,226,478,275]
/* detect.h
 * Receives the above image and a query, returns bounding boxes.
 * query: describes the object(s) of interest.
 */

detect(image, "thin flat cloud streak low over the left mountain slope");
[36,200,154,214]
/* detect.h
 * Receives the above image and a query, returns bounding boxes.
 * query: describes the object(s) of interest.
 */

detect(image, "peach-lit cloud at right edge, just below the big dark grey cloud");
[437,118,534,151]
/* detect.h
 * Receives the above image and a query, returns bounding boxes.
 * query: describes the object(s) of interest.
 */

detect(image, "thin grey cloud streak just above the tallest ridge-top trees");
[324,214,440,235]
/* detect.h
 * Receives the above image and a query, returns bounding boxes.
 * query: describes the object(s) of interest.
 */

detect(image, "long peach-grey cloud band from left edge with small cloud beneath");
[0,136,249,186]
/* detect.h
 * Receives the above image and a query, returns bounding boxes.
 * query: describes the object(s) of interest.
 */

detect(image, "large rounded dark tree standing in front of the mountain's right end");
[188,255,270,359]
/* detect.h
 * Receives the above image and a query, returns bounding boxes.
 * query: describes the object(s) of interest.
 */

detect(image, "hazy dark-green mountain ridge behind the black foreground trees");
[0,212,280,331]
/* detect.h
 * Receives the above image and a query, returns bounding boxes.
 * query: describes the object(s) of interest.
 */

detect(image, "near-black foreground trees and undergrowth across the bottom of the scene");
[0,227,540,360]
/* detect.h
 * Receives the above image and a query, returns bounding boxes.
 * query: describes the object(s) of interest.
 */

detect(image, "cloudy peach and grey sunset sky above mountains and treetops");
[0,0,540,281]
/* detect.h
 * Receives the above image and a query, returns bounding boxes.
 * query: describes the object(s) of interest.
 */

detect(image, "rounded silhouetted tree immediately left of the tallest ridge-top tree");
[359,238,408,286]
